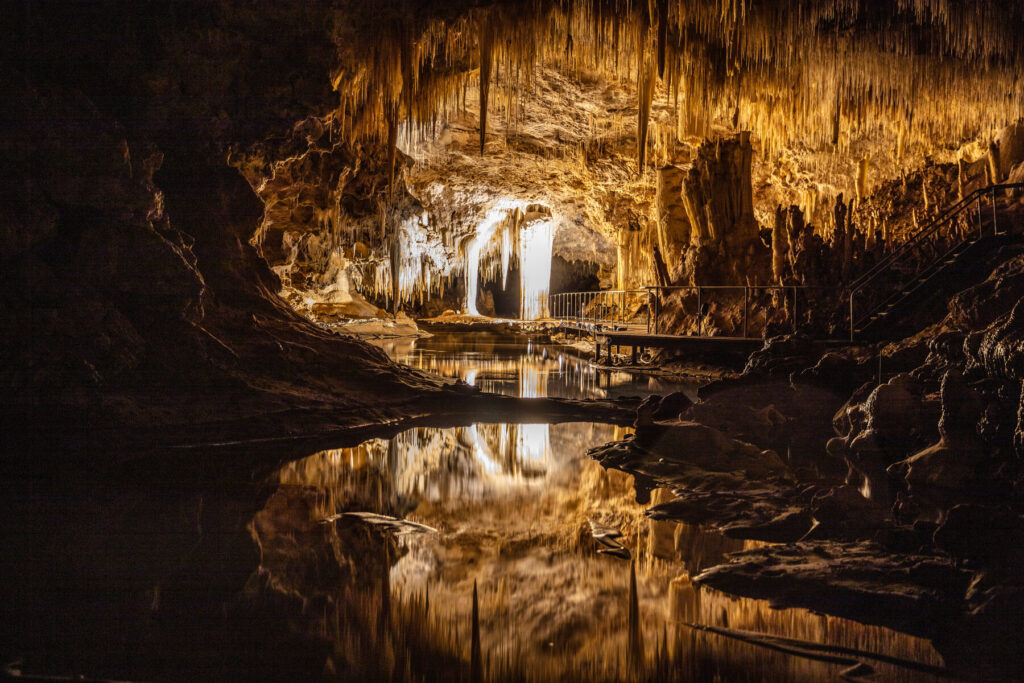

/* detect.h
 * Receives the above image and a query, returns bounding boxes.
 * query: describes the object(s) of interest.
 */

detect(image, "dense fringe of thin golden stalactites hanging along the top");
[332,0,1024,167]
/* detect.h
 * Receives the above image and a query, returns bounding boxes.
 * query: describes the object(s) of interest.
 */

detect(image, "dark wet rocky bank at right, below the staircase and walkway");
[591,245,1024,678]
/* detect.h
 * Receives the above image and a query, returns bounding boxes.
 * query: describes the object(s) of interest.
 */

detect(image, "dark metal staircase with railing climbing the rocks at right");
[846,183,1024,341]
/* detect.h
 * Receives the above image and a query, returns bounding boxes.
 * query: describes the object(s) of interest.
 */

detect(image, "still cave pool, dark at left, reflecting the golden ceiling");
[0,335,940,681]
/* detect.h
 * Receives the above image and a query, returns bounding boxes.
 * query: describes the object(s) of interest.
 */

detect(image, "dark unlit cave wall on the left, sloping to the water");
[0,1,456,443]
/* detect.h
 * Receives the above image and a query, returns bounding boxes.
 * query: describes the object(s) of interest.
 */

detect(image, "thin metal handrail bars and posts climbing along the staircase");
[847,182,1024,341]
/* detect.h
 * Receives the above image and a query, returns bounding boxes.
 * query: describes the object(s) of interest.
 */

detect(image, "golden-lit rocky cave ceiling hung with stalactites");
[243,0,1024,307]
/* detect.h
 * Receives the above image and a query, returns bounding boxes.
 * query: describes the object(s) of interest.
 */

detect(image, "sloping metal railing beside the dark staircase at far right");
[847,182,1024,341]
